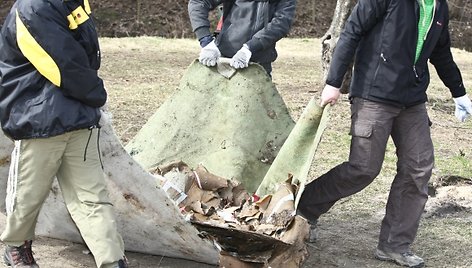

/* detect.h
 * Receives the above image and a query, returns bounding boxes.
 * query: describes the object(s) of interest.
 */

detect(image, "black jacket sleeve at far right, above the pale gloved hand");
[429,8,465,98]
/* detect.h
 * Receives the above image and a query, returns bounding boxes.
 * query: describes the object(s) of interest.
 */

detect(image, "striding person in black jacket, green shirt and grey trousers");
[298,0,472,267]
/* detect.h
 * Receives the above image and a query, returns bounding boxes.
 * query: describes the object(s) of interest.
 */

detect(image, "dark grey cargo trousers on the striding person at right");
[298,98,434,253]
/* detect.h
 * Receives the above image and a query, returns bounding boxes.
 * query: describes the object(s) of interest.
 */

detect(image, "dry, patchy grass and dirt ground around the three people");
[0,37,472,268]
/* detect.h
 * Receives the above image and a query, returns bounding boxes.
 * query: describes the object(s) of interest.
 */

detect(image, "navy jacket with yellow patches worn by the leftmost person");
[0,0,107,140]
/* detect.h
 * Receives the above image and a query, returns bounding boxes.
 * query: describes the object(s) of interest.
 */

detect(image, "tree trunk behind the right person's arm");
[321,0,356,93]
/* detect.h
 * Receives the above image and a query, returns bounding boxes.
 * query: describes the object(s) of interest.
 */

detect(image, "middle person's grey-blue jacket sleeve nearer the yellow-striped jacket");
[188,0,224,40]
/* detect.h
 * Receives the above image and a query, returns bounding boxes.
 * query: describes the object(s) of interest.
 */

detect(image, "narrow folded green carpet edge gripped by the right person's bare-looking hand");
[256,98,330,206]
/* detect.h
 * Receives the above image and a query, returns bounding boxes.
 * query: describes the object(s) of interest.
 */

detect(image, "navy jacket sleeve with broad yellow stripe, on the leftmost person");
[16,0,106,107]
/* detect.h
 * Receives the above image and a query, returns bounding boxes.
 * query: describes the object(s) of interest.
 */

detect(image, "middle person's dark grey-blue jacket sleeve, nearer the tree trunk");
[247,0,297,52]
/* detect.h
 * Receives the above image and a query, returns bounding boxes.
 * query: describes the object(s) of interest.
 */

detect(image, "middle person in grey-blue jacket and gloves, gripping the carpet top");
[188,0,296,75]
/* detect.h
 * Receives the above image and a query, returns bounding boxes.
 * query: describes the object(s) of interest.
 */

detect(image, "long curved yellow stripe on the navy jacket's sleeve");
[16,11,61,87]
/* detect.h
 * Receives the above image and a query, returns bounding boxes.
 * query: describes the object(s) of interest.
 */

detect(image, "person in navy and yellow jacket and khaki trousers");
[0,0,127,267]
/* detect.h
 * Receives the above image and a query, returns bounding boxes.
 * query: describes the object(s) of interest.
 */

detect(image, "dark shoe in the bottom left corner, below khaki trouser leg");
[3,240,39,268]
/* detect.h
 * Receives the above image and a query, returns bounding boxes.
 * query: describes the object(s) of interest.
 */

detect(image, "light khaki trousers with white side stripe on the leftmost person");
[1,128,124,267]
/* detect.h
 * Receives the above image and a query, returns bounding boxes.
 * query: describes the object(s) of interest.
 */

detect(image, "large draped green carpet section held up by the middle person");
[126,61,295,192]
